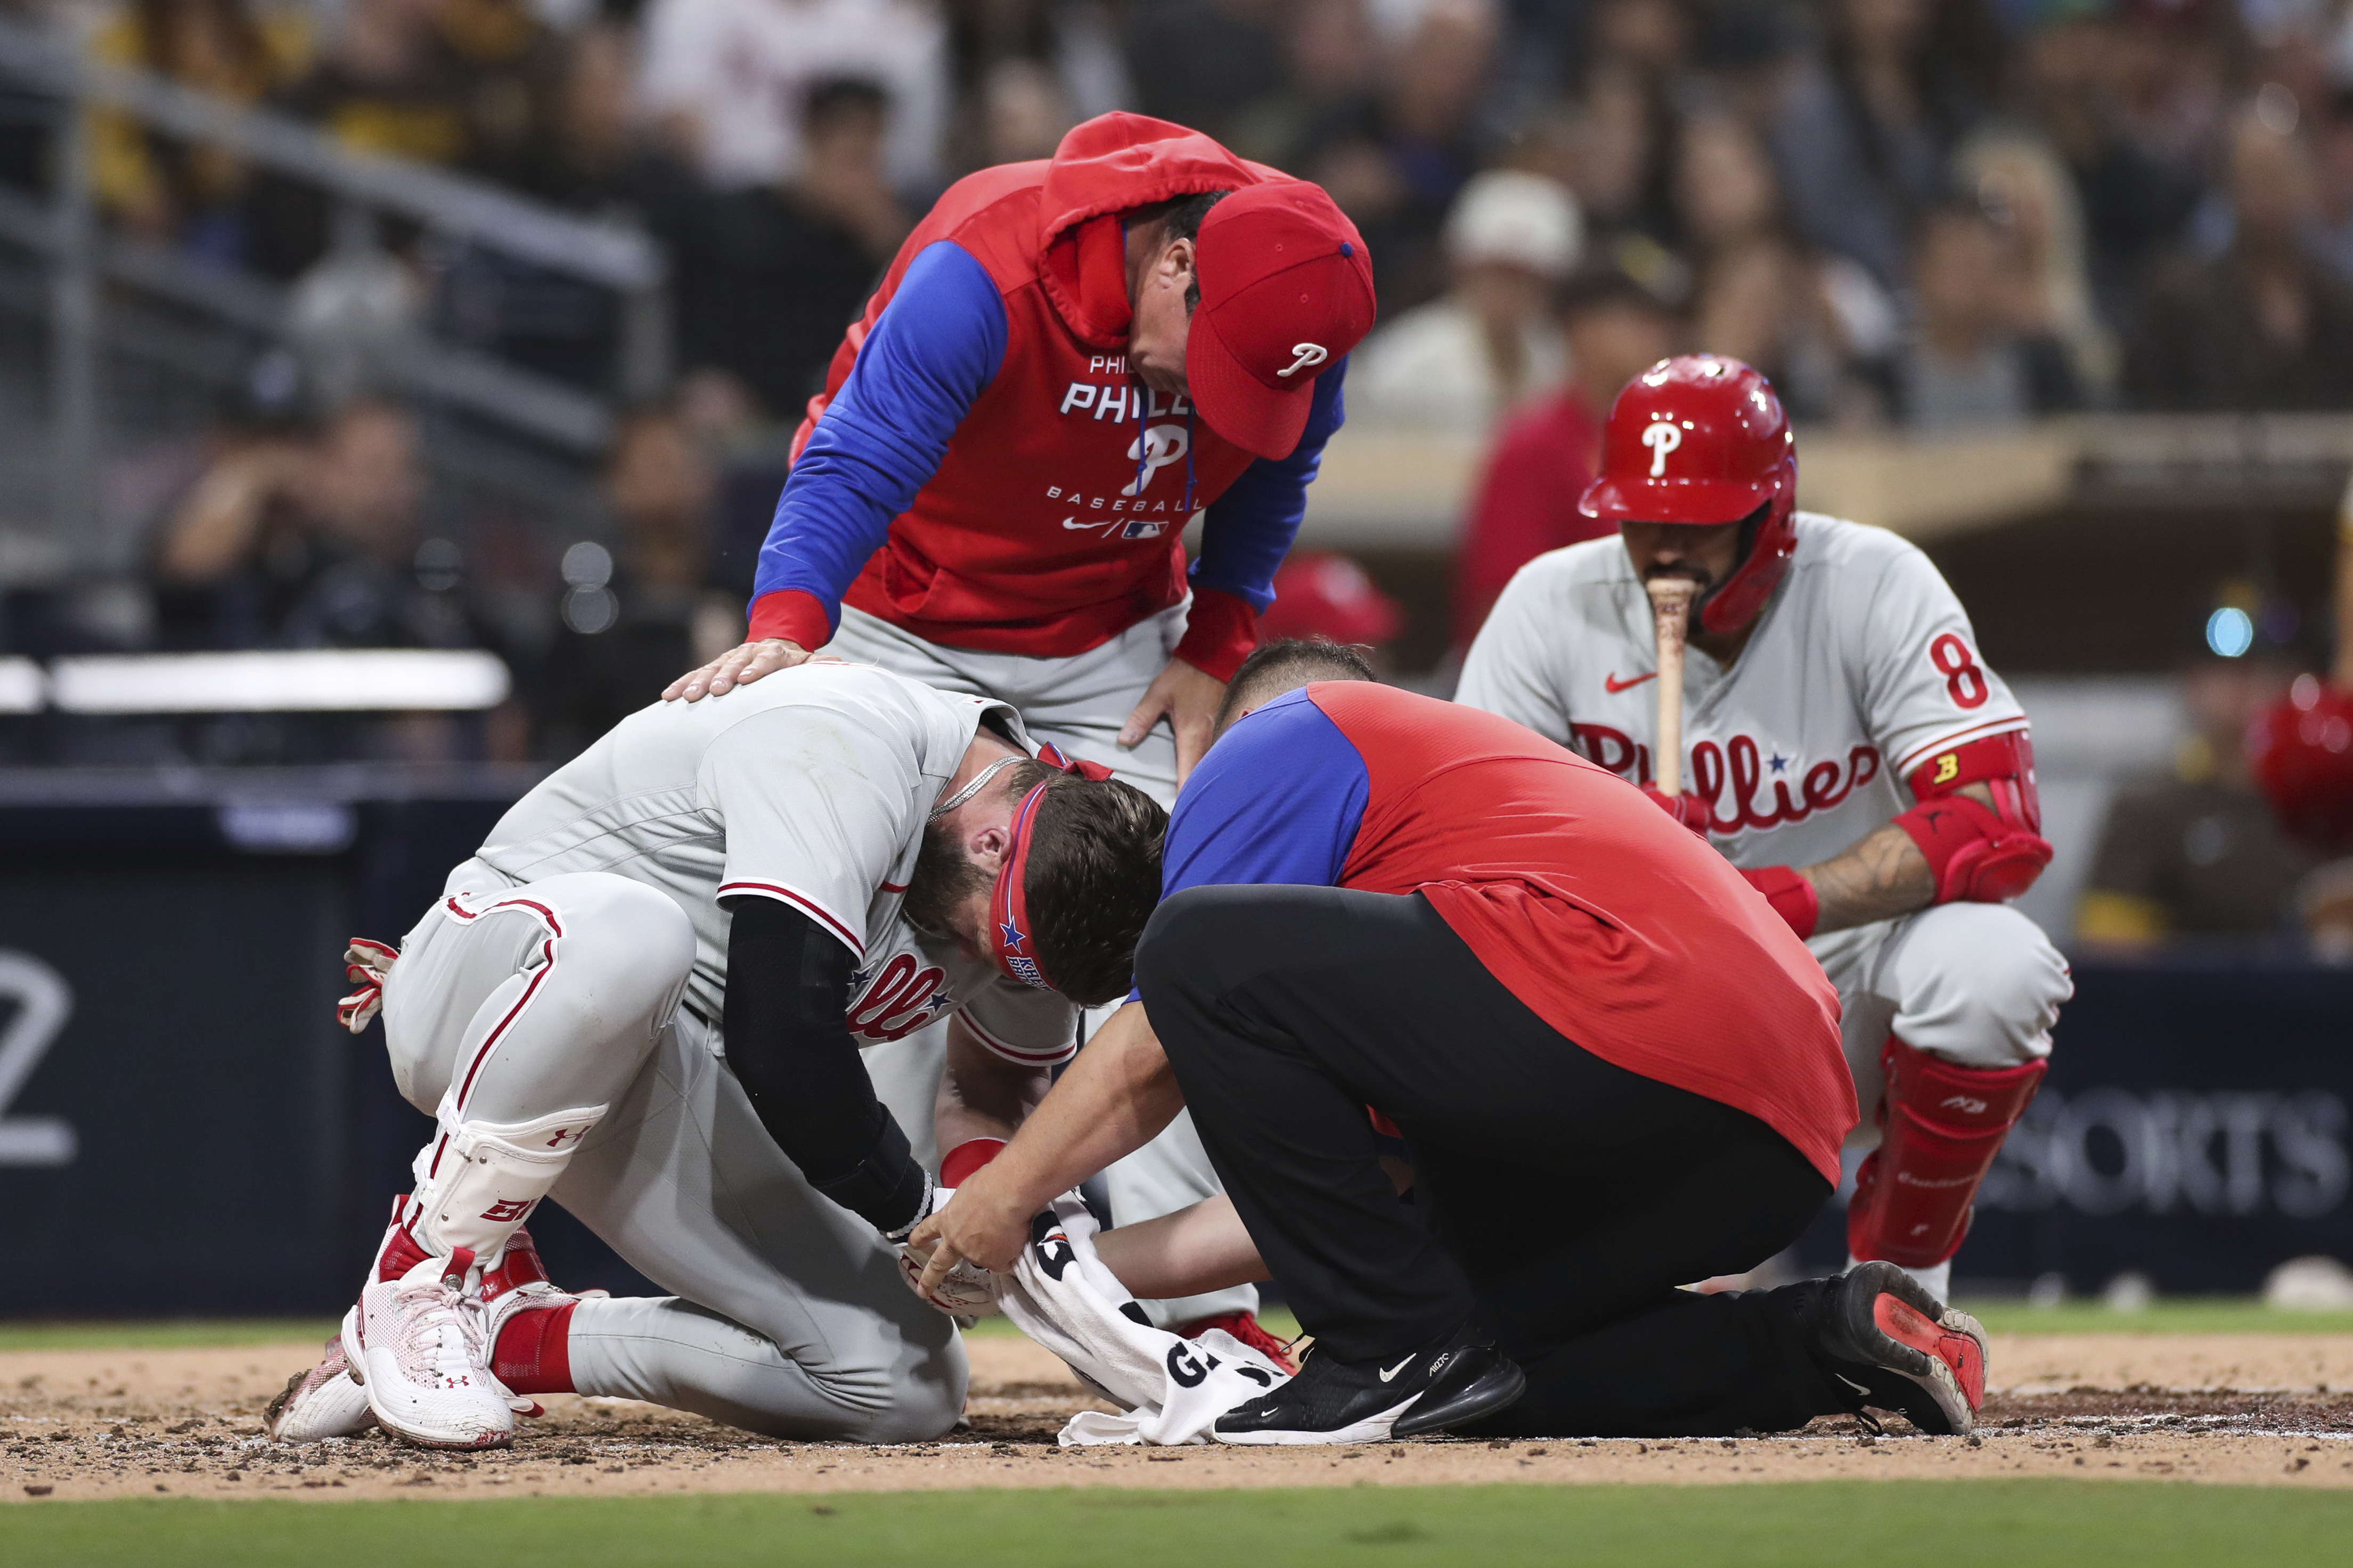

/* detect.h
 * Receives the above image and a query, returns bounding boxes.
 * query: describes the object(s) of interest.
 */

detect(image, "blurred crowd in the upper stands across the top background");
[27,0,2353,430]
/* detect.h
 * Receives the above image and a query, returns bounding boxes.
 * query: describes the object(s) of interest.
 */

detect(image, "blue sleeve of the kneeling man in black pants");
[1160,691,1372,898]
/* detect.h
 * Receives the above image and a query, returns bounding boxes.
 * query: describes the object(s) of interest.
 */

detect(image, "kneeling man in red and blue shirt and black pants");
[911,644,1986,1443]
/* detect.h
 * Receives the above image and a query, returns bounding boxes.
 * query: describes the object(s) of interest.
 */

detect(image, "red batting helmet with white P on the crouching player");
[1576,355,1798,633]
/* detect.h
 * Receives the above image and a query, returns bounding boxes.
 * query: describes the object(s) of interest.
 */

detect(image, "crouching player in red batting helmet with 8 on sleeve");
[1457,355,2073,1298]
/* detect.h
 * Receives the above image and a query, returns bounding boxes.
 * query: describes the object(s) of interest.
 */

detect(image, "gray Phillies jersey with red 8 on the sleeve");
[1454,513,2026,865]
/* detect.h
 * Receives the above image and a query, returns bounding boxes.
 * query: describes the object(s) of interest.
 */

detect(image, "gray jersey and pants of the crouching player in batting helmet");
[1457,513,2073,1145]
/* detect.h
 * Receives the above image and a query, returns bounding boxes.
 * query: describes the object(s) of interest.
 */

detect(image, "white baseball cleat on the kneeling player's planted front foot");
[344,1246,516,1448]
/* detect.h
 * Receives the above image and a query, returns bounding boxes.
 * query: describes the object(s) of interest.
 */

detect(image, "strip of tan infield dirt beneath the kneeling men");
[0,1333,2353,1502]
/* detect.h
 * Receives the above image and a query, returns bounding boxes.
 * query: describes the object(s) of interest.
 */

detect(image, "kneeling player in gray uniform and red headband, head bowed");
[271,663,1167,1448]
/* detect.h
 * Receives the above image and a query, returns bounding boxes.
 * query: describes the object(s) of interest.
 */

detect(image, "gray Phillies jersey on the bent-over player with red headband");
[475,663,1077,1065]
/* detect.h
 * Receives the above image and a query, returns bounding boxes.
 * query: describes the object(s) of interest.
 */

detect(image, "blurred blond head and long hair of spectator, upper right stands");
[1955,129,2118,404]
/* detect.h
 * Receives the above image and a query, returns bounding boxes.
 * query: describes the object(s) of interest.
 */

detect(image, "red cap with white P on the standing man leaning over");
[1183,179,1374,458]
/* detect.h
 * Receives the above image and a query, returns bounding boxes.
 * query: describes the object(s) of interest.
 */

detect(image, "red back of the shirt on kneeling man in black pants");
[1308,682,1854,1185]
